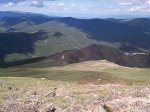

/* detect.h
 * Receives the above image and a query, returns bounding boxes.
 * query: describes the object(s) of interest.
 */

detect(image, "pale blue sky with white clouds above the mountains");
[0,0,150,17]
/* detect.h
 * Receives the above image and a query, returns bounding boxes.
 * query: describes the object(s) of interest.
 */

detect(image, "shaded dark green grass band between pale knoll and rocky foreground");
[0,68,115,81]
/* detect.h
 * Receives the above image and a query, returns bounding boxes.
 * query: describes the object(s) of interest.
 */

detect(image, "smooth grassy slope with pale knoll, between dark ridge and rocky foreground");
[0,61,150,84]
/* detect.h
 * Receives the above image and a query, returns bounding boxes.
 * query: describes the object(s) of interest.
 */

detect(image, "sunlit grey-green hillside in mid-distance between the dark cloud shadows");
[5,21,119,62]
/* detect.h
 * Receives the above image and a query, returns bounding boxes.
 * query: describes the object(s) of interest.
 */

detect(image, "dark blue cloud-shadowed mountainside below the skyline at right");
[58,17,150,43]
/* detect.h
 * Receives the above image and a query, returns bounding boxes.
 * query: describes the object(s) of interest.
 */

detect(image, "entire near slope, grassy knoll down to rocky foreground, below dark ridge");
[0,61,150,112]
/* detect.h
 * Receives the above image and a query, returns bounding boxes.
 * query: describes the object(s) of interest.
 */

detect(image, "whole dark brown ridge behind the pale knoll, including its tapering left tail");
[2,44,150,68]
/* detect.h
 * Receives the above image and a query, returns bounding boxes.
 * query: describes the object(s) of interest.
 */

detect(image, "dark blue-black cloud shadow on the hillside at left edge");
[0,32,47,66]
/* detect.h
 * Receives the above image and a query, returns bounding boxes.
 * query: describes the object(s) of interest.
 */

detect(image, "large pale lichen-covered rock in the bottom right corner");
[106,97,150,112]
